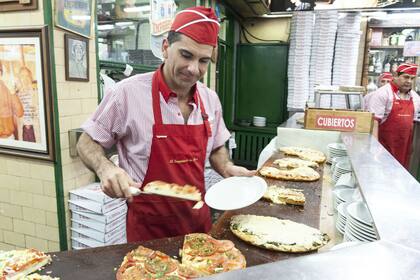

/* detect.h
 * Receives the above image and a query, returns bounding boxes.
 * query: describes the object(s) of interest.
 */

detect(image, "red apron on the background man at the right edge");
[378,93,414,168]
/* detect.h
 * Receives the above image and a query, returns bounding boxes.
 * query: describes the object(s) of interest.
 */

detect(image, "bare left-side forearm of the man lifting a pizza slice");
[77,132,112,177]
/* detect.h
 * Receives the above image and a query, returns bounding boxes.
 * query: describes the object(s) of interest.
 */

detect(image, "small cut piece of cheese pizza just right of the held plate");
[263,186,305,205]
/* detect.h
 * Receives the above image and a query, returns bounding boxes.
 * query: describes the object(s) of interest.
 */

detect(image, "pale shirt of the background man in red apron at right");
[365,82,420,123]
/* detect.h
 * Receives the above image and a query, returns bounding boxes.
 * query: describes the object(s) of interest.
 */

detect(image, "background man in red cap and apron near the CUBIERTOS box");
[367,63,420,168]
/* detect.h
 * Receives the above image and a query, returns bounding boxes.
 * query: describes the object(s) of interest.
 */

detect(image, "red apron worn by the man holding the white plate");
[127,73,212,242]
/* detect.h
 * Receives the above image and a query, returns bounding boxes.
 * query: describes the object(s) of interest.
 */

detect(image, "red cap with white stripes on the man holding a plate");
[171,7,220,47]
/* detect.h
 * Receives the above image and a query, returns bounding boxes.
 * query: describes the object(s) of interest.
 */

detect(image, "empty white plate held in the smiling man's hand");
[204,176,267,210]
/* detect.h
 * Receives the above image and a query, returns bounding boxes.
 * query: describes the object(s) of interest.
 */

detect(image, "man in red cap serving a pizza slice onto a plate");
[78,7,255,242]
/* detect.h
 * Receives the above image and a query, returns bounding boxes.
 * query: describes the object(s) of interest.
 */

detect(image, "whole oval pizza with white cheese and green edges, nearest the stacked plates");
[230,215,330,253]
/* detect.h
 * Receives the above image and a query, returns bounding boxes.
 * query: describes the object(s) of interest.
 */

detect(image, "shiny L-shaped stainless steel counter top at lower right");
[208,120,420,280]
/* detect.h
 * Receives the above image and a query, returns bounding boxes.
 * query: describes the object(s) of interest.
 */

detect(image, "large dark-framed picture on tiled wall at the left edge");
[0,27,55,161]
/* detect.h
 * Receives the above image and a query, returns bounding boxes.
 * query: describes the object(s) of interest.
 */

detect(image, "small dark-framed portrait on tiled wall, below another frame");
[64,34,89,82]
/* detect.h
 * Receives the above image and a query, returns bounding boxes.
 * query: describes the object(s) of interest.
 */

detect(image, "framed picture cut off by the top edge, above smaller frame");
[55,0,93,38]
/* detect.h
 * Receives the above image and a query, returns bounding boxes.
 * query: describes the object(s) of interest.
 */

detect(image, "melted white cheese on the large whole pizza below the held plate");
[231,215,325,248]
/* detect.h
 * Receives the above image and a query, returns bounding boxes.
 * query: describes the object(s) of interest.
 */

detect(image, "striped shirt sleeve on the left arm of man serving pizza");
[82,87,124,149]
